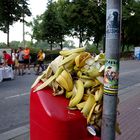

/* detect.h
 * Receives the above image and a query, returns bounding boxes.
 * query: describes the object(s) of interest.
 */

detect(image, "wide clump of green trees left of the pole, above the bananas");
[30,0,106,49]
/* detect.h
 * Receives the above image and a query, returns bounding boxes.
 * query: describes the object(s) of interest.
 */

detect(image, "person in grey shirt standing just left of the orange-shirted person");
[17,47,24,75]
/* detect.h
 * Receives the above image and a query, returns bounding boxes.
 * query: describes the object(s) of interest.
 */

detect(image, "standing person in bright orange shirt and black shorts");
[24,46,30,74]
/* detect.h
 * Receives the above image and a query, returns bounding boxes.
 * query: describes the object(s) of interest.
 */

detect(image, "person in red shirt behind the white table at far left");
[3,50,13,67]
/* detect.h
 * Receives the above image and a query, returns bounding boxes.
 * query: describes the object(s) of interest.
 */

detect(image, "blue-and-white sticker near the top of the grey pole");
[106,9,120,39]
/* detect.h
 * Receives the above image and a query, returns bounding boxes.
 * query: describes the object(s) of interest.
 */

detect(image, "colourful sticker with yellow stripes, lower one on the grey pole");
[104,59,119,95]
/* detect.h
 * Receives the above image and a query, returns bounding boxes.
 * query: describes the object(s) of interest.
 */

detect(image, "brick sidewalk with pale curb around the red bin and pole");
[0,83,140,140]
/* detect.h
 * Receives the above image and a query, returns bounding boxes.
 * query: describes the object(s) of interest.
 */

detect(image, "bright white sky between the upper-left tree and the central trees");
[0,0,47,42]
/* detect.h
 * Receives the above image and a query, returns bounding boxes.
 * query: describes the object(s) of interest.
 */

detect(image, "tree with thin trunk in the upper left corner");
[0,0,31,47]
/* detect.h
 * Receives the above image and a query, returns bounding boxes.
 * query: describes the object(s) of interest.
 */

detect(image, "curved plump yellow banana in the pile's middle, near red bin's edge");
[69,79,84,107]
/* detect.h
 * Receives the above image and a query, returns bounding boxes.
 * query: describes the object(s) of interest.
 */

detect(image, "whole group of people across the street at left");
[1,47,45,76]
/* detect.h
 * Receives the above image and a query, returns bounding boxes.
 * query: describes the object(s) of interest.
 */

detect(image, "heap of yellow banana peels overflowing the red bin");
[32,48,120,136]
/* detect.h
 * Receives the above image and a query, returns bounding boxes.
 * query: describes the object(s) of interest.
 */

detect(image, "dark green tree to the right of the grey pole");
[122,0,140,52]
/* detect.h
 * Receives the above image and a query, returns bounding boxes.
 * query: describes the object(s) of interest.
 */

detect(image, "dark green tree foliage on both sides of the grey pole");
[30,0,140,48]
